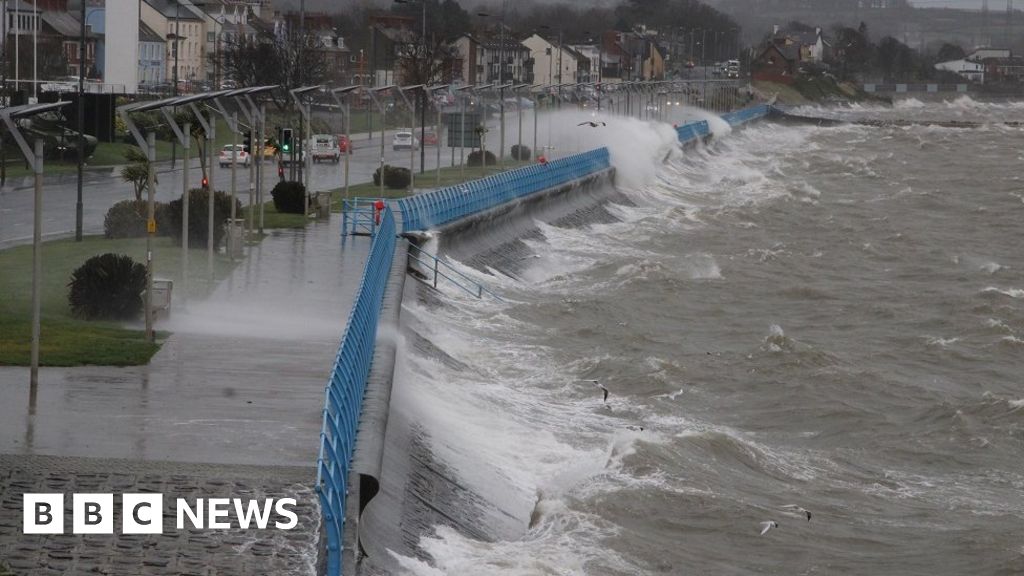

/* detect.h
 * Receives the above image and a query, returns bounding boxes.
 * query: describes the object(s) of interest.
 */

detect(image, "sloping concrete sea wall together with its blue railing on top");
[315,105,769,576]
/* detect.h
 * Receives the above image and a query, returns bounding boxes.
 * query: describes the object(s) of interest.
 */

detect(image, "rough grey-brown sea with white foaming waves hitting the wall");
[378,96,1024,576]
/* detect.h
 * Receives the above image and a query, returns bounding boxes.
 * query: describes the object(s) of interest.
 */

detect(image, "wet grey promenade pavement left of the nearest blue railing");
[0,215,370,574]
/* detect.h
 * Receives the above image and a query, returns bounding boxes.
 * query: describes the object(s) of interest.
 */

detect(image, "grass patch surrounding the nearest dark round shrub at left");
[0,236,234,366]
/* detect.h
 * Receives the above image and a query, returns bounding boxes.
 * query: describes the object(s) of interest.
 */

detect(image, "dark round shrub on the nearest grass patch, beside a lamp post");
[68,253,145,320]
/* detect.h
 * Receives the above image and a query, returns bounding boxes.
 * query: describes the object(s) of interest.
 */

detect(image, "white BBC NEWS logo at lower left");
[22,493,299,534]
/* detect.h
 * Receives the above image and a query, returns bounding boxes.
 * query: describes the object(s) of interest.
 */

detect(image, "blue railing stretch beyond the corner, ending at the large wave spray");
[398,148,611,233]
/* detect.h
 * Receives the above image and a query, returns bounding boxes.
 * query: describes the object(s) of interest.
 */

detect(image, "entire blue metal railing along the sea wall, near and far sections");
[316,106,769,576]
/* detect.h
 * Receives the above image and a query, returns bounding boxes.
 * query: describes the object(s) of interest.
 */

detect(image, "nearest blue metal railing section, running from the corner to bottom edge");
[316,203,396,576]
